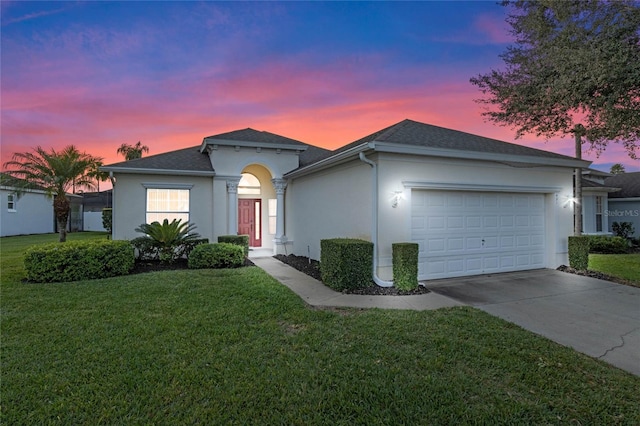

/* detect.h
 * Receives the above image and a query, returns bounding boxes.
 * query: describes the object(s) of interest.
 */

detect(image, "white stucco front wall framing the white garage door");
[370,154,573,279]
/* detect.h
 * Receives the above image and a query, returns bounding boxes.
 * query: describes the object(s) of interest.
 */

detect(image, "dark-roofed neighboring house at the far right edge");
[604,172,640,238]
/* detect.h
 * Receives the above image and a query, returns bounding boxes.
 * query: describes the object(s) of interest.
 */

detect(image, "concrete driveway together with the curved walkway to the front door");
[251,256,640,376]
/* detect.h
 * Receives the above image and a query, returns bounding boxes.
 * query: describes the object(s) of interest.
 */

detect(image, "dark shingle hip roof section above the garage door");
[334,119,584,159]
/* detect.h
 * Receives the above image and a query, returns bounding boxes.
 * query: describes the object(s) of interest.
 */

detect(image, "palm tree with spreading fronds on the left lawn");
[4,145,102,243]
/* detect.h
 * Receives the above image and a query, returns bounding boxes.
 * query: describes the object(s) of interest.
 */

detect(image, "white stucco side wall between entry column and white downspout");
[285,160,372,260]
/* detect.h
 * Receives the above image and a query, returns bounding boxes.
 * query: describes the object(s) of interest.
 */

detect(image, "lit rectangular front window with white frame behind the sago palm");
[146,188,189,223]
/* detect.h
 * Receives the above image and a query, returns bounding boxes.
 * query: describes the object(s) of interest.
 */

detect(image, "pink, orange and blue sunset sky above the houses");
[1,1,640,171]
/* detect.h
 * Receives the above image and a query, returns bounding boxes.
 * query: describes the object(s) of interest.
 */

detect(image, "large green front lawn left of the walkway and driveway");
[0,234,640,425]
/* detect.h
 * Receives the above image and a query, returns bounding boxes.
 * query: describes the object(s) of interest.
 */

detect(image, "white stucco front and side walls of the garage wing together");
[287,153,573,280]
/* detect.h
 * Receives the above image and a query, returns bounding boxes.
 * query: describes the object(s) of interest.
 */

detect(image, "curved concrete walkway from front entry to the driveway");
[251,257,464,311]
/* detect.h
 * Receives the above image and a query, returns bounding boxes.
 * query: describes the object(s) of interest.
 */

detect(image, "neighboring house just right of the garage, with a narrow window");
[582,169,620,235]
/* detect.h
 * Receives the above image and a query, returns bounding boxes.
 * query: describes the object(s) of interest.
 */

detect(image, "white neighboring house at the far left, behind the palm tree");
[0,173,55,237]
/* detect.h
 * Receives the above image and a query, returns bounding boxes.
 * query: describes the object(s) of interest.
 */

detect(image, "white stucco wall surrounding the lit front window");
[113,173,215,241]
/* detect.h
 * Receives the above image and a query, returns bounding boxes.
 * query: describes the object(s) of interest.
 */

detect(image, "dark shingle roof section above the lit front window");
[105,146,213,172]
